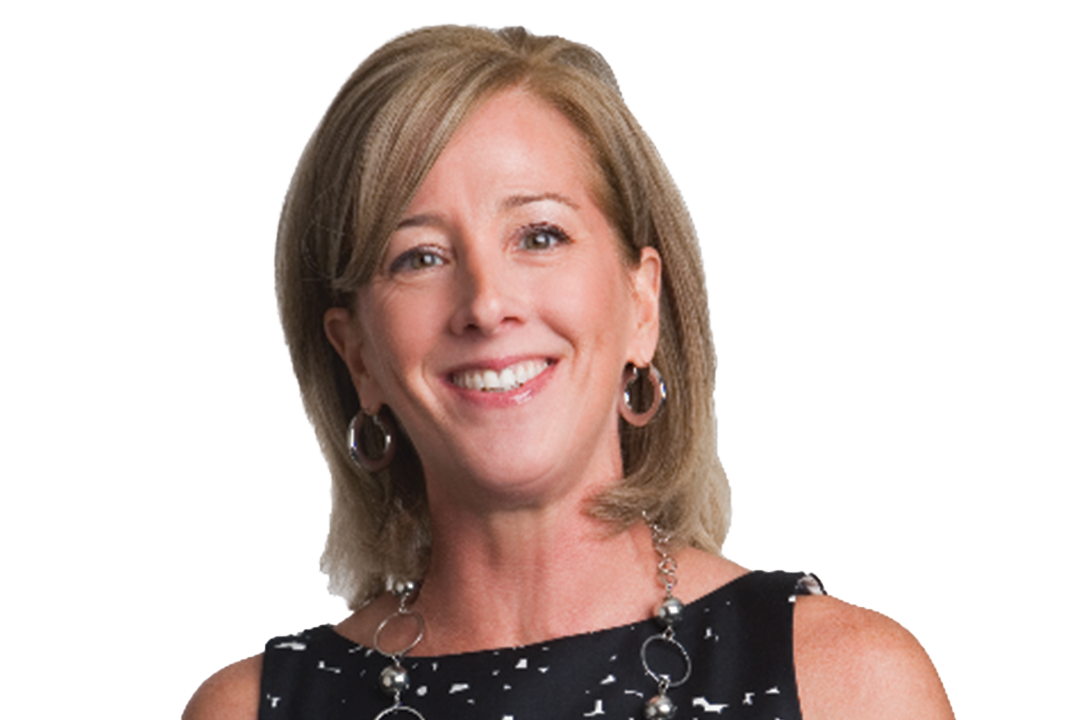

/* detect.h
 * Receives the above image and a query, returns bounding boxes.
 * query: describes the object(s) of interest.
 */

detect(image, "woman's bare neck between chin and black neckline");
[414,504,663,655]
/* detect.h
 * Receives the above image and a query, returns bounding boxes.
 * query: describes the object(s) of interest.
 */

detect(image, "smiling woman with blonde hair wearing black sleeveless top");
[184,26,954,720]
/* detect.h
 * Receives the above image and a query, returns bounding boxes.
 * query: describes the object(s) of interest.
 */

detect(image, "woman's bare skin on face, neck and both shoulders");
[181,91,955,720]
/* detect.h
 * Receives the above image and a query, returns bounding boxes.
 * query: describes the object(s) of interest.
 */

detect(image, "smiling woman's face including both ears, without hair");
[326,91,660,503]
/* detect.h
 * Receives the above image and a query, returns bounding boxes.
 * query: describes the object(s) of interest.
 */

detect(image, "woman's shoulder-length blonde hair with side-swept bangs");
[274,25,733,609]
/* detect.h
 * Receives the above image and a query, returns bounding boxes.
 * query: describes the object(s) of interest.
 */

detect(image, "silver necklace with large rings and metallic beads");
[375,522,691,720]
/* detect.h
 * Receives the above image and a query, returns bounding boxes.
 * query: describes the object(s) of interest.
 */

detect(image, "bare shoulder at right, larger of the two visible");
[794,596,956,720]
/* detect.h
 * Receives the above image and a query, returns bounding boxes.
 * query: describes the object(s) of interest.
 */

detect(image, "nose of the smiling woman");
[450,246,521,336]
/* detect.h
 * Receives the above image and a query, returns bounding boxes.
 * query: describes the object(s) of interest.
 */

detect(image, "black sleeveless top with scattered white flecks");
[259,571,824,720]
